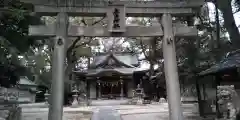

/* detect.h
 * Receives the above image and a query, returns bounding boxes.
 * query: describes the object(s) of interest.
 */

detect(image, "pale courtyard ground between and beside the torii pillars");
[19,101,199,120]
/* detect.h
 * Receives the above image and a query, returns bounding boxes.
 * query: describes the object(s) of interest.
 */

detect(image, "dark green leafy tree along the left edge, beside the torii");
[0,0,39,87]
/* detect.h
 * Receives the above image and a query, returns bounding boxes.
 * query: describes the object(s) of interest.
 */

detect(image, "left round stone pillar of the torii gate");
[48,12,68,120]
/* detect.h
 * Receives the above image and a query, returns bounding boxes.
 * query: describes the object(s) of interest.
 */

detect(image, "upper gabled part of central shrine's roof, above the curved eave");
[90,53,139,68]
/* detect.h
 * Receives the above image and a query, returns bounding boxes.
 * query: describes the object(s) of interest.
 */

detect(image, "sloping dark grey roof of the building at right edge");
[199,49,240,76]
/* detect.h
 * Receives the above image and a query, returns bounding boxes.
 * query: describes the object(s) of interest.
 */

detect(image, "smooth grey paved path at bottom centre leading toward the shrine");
[91,107,121,120]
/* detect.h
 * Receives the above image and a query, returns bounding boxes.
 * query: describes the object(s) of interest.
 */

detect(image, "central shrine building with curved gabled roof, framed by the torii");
[74,52,148,99]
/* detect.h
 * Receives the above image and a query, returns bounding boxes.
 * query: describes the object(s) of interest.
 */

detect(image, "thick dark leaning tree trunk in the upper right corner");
[217,0,240,49]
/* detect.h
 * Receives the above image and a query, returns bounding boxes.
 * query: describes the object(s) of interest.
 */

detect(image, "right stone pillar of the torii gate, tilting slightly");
[162,14,183,120]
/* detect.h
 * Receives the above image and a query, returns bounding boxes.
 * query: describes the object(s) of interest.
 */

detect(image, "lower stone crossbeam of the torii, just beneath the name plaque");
[29,24,198,37]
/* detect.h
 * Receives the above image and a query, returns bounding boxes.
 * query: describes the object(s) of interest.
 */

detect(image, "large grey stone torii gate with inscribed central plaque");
[21,0,204,120]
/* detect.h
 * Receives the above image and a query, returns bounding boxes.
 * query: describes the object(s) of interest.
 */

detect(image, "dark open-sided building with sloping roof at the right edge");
[197,50,240,116]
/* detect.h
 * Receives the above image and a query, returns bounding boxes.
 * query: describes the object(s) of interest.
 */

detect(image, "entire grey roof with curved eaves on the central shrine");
[74,53,149,77]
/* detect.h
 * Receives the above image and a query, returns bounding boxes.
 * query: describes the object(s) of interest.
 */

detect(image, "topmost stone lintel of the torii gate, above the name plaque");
[18,0,204,17]
